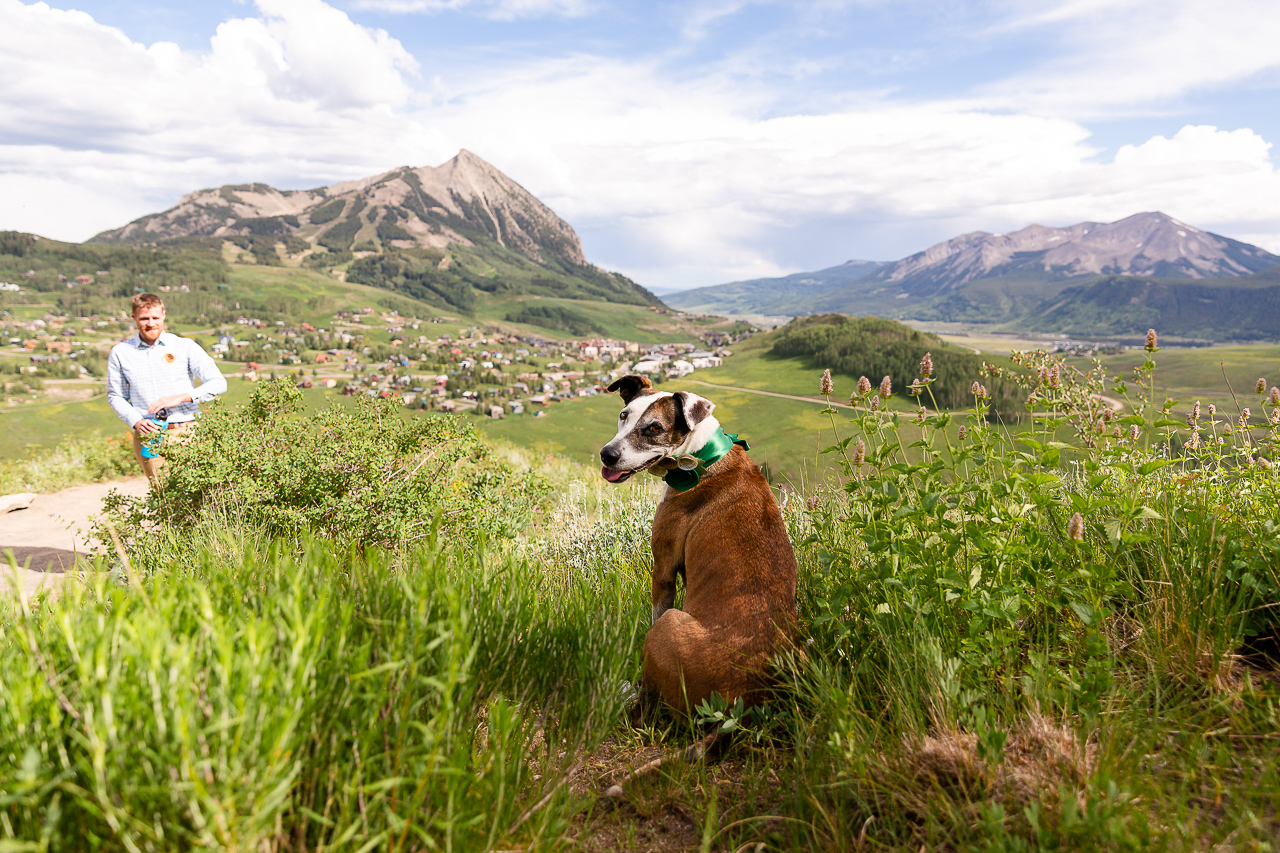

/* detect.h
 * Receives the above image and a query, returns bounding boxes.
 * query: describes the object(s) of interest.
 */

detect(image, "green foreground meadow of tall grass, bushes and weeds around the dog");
[0,333,1280,852]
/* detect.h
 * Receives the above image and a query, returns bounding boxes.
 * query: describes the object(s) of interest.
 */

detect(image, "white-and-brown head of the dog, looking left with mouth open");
[600,375,719,483]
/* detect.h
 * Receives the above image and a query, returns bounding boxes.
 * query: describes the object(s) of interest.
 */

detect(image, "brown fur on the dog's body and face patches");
[609,380,796,713]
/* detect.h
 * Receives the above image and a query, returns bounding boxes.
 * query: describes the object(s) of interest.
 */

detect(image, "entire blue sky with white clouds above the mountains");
[0,0,1280,289]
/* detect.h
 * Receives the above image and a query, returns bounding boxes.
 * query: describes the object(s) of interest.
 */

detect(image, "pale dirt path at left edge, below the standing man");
[0,476,147,596]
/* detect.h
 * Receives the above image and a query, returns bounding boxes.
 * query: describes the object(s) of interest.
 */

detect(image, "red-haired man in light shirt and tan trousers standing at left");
[106,293,227,485]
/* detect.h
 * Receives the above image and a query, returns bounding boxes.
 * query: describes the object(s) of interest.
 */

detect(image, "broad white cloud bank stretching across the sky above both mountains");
[0,0,1280,286]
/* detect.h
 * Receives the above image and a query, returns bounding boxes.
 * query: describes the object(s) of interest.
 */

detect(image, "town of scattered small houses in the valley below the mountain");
[0,300,754,419]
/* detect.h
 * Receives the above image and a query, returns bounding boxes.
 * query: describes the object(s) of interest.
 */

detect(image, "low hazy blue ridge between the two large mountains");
[664,260,883,315]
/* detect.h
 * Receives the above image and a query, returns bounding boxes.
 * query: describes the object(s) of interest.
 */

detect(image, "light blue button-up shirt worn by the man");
[106,332,227,429]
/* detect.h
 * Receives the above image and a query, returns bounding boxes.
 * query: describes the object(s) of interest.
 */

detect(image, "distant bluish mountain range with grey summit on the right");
[664,213,1280,339]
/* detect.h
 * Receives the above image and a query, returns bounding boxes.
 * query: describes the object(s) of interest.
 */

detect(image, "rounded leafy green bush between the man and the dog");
[99,379,544,552]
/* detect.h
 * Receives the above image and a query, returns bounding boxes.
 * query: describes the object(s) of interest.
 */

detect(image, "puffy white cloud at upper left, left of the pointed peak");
[0,0,452,240]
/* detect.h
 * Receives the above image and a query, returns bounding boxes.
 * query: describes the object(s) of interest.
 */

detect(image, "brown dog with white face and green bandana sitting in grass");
[600,375,796,713]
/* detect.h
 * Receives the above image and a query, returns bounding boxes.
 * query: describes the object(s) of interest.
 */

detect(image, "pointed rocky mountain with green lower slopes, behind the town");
[92,150,662,310]
